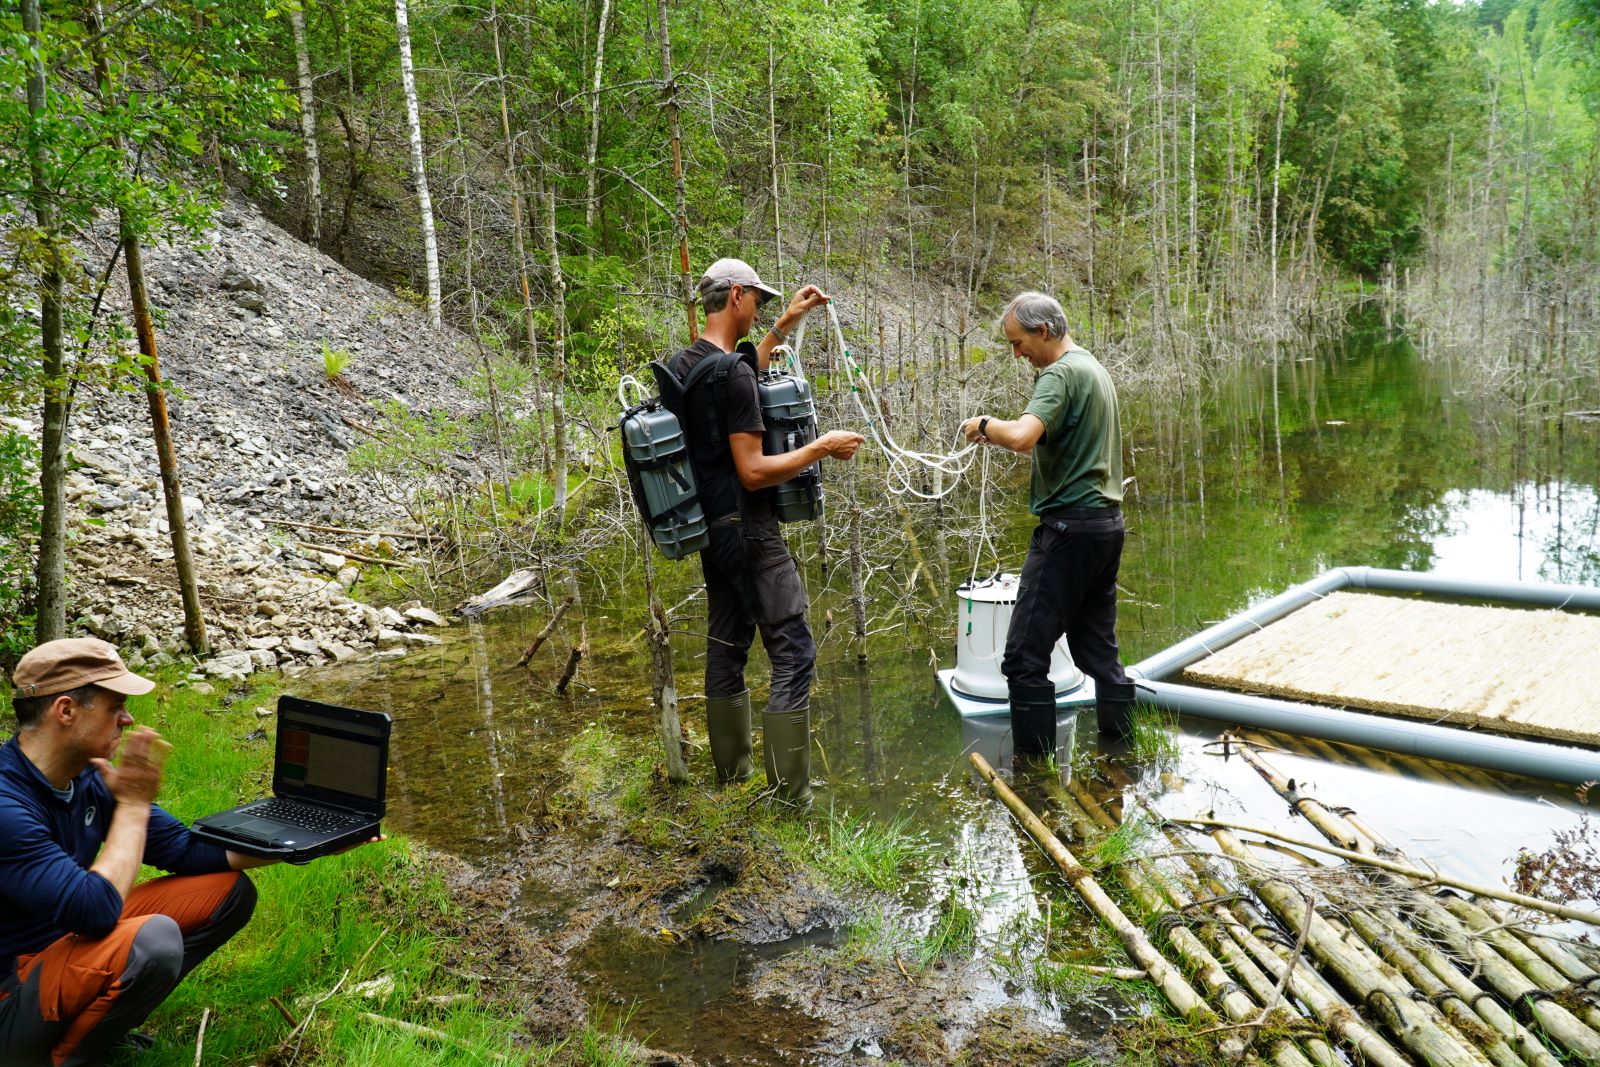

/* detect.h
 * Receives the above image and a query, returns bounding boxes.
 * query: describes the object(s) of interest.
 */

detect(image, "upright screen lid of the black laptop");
[272,696,390,816]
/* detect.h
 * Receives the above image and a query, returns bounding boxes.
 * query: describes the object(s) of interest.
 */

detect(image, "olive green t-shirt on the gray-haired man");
[1024,347,1122,515]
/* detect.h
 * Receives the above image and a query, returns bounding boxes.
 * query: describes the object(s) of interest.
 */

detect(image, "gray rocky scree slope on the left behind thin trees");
[16,202,477,677]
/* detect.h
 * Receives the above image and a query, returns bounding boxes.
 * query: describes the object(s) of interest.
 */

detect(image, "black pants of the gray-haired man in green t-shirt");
[1000,512,1128,689]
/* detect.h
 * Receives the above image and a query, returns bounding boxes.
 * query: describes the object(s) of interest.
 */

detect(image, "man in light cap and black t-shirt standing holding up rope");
[670,259,862,806]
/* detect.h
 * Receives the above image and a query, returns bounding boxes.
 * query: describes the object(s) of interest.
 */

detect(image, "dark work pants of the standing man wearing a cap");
[701,522,816,712]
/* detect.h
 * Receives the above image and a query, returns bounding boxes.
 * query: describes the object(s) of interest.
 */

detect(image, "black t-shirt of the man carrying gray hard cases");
[670,338,776,523]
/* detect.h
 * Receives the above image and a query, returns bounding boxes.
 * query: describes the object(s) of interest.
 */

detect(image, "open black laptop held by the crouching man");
[190,696,392,864]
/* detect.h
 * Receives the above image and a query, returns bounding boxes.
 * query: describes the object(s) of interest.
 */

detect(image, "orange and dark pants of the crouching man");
[0,870,256,1067]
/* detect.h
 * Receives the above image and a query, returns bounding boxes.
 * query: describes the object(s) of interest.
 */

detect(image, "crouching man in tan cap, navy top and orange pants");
[0,638,264,1067]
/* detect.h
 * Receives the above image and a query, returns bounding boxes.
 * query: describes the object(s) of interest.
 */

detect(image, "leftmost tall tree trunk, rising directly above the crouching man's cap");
[22,0,70,641]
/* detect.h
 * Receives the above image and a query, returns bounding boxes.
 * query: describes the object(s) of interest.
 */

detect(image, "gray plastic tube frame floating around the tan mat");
[1128,566,1600,784]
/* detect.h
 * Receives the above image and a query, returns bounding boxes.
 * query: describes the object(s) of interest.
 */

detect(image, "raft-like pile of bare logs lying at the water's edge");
[971,742,1600,1067]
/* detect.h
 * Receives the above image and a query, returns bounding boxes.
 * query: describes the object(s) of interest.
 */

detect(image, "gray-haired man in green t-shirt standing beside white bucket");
[962,293,1133,755]
